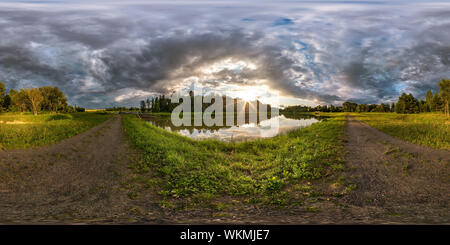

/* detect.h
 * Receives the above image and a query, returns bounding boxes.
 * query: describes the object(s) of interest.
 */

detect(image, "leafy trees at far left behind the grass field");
[0,82,85,115]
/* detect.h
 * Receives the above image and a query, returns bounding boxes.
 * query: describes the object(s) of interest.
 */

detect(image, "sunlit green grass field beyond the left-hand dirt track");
[0,112,110,150]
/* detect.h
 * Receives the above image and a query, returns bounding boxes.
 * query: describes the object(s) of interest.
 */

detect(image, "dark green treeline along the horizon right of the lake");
[283,79,450,116]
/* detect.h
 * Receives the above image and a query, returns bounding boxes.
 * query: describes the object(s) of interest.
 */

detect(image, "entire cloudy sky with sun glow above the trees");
[0,0,450,108]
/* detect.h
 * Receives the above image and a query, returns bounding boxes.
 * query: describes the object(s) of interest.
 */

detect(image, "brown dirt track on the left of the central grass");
[0,116,134,223]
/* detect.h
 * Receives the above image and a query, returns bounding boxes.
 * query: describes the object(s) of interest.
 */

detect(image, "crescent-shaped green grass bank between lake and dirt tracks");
[122,114,345,205]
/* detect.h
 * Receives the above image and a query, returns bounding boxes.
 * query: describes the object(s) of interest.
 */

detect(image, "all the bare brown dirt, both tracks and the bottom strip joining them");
[0,116,450,224]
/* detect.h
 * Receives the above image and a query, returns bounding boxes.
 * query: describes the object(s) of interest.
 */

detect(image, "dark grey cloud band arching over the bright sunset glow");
[95,30,338,101]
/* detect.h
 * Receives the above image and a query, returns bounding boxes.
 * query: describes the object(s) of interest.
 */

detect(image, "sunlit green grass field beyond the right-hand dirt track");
[352,112,450,150]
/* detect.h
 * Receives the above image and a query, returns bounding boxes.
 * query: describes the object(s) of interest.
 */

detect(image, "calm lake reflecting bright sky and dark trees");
[142,114,324,142]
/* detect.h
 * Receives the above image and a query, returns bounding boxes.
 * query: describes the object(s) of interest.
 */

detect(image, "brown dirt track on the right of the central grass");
[345,116,450,223]
